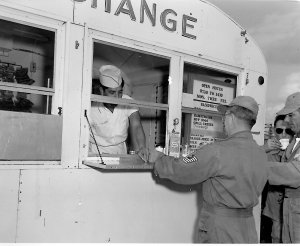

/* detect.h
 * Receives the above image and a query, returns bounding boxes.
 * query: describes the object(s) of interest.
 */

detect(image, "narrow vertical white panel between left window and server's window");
[62,24,87,166]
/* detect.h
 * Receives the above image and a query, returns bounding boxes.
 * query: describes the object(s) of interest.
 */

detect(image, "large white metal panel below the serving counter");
[17,169,197,243]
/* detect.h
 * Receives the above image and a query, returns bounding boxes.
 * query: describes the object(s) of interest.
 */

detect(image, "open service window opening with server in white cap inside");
[84,41,170,168]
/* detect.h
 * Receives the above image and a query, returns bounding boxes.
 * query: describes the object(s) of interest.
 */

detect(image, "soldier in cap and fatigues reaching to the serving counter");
[150,96,267,243]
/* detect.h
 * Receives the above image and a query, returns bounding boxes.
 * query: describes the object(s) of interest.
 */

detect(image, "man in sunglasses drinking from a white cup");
[262,115,294,243]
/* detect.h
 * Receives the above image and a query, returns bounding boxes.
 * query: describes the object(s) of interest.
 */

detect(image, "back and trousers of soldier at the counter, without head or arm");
[197,131,267,243]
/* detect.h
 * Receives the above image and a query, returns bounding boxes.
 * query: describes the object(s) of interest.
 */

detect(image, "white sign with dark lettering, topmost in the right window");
[193,80,234,111]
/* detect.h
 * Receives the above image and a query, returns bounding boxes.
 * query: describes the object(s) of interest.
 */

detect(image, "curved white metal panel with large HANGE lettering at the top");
[74,0,250,65]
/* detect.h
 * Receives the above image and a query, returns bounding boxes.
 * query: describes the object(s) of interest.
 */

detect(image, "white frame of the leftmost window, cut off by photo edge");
[0,7,67,169]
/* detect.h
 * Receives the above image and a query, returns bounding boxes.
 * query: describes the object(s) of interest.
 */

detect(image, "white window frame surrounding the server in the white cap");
[79,27,182,166]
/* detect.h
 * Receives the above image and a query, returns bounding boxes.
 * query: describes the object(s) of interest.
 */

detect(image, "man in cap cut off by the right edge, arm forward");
[269,92,300,243]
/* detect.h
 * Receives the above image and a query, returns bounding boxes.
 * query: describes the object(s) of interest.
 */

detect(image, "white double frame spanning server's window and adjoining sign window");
[79,27,246,165]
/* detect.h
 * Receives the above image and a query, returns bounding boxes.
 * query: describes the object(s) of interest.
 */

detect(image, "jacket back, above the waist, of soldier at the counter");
[203,131,267,208]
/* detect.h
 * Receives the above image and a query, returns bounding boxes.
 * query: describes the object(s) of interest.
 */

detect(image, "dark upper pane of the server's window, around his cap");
[92,43,170,104]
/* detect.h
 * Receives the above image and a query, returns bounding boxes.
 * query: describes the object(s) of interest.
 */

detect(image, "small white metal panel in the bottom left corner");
[0,170,20,243]
